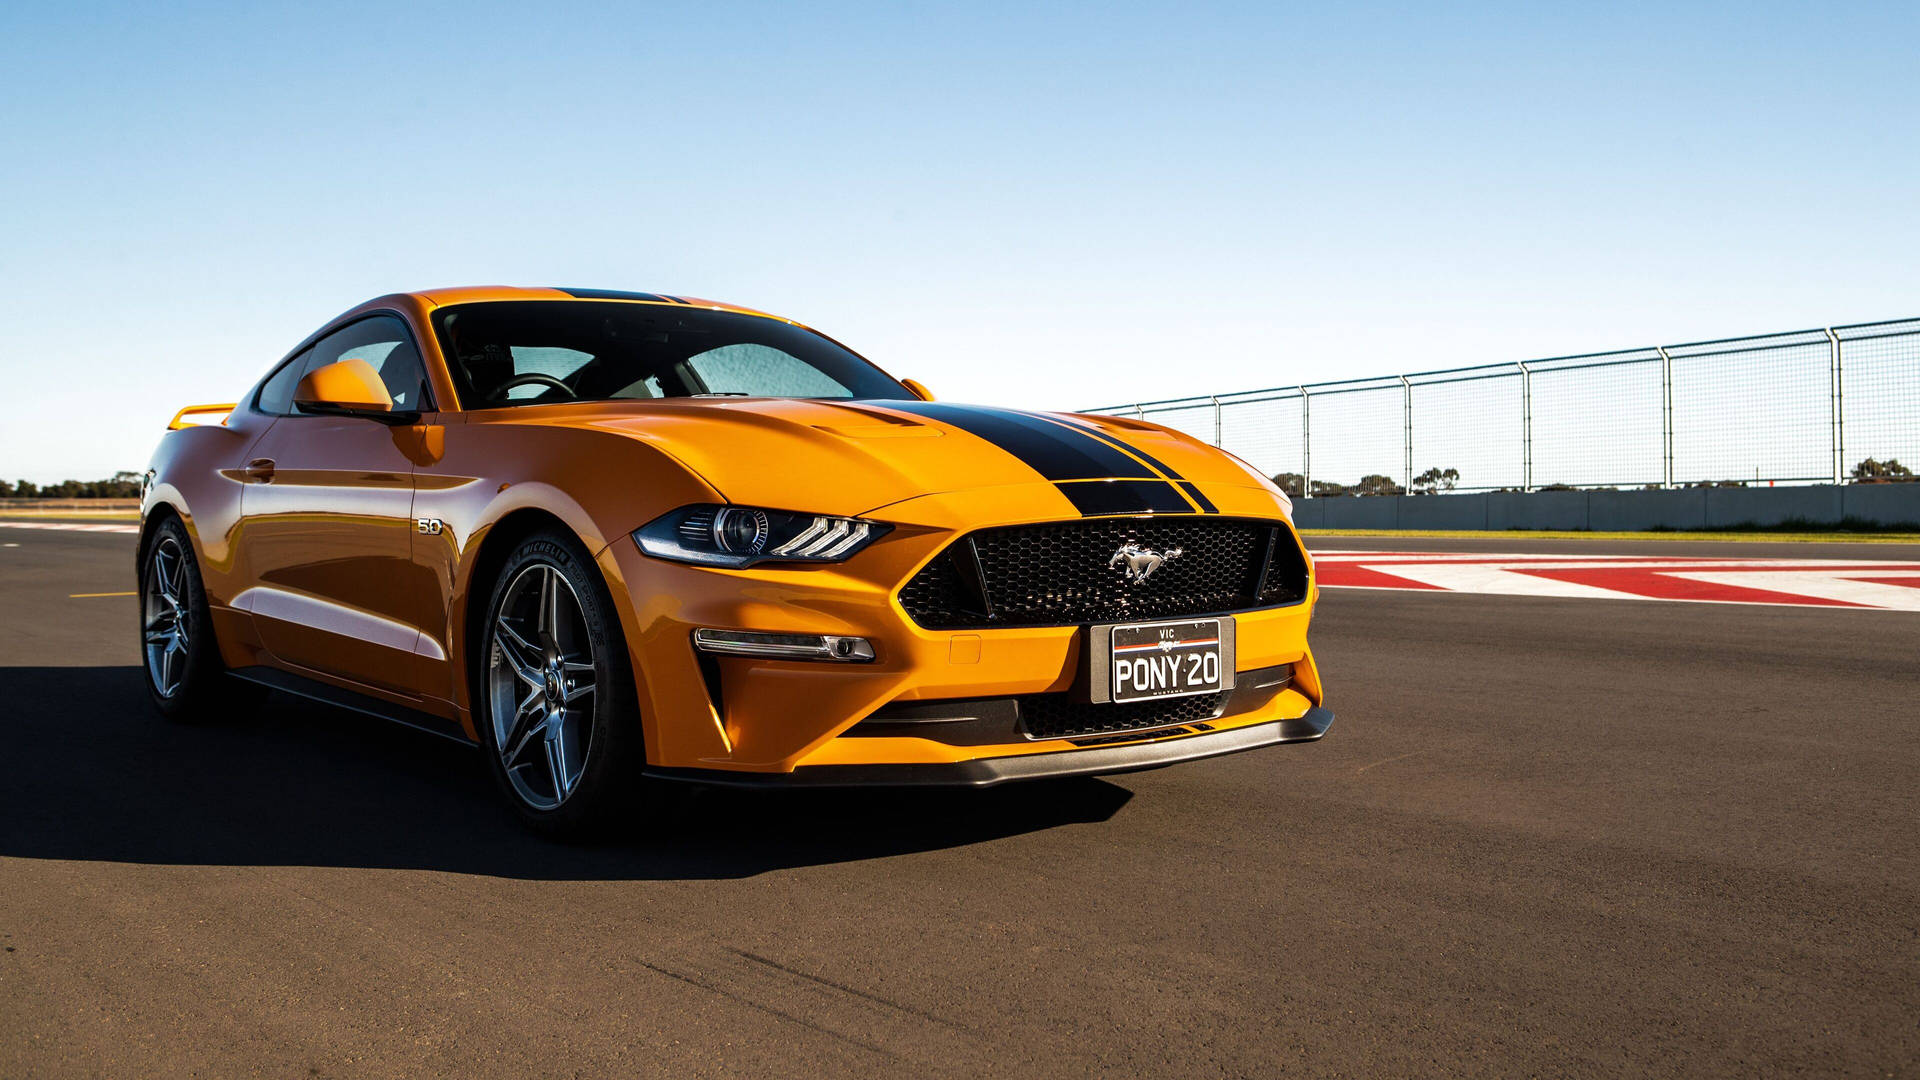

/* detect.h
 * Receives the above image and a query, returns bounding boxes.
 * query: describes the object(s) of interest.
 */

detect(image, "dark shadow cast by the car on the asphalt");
[0,665,1131,880]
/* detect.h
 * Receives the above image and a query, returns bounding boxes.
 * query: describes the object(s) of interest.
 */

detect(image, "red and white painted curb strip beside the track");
[1313,552,1920,611]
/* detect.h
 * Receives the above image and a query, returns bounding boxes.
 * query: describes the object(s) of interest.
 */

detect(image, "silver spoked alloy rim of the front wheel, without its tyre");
[488,563,595,811]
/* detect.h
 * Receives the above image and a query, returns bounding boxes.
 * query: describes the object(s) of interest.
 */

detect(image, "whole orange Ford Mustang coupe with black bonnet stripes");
[138,288,1332,832]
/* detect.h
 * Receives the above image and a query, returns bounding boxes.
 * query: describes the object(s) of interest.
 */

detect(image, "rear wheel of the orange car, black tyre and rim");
[138,517,265,724]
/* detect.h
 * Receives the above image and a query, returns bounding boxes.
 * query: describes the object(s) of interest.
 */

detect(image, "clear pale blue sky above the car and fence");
[0,2,1920,482]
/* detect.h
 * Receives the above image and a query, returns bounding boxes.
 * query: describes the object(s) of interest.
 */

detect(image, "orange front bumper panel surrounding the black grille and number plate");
[599,484,1325,772]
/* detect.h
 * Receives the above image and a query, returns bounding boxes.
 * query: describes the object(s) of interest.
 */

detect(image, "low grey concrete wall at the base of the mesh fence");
[1294,482,1920,532]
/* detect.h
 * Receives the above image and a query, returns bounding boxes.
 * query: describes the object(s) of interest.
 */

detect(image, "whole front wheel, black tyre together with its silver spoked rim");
[472,532,645,838]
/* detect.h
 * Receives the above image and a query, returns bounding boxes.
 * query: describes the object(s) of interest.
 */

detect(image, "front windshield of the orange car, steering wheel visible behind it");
[434,300,914,409]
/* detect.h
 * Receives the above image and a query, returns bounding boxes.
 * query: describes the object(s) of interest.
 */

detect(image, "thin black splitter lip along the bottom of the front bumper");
[647,705,1332,788]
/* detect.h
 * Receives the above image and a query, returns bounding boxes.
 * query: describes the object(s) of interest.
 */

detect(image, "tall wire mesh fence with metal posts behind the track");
[1087,319,1920,496]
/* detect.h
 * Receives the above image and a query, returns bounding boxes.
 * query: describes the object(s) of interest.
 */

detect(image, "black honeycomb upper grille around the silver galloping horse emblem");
[900,517,1308,630]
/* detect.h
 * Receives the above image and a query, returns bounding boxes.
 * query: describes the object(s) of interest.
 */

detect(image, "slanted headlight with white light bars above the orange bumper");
[634,503,893,567]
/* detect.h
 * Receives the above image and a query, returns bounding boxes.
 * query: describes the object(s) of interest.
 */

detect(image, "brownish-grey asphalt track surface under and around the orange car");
[0,528,1920,1078]
